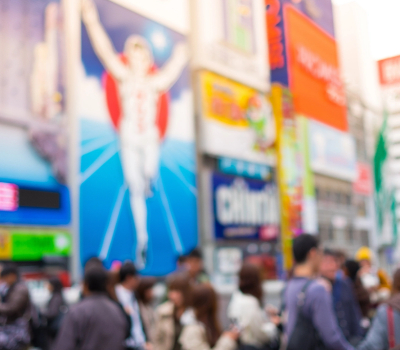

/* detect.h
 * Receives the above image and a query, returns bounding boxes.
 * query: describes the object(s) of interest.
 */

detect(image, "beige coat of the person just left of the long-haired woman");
[153,301,175,350]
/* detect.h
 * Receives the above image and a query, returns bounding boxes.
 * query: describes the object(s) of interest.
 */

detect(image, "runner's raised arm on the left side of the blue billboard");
[82,0,127,80]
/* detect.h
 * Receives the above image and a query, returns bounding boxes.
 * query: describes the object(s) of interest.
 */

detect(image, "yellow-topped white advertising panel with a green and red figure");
[199,71,276,164]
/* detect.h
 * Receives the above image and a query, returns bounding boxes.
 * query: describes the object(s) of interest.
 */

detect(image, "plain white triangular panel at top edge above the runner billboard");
[111,0,190,34]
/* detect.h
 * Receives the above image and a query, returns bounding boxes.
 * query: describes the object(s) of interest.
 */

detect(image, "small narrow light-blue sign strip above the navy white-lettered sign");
[218,157,272,181]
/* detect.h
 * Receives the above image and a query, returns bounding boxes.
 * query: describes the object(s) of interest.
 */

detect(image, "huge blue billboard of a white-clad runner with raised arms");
[78,0,197,275]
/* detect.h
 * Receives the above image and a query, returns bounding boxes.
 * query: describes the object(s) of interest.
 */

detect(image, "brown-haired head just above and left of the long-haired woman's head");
[168,273,192,309]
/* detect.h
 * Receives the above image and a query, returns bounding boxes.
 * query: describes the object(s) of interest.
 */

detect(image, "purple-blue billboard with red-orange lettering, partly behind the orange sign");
[264,0,334,86]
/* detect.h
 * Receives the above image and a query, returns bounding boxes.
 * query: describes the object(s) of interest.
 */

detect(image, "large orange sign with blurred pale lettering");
[284,5,348,131]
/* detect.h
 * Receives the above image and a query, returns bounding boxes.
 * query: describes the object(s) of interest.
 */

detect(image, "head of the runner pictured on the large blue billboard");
[124,35,154,76]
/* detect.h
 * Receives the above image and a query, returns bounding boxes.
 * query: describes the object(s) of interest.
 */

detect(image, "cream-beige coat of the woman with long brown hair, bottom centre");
[179,322,237,350]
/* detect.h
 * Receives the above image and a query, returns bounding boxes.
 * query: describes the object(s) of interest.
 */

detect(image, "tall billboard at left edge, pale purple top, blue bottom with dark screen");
[0,0,70,225]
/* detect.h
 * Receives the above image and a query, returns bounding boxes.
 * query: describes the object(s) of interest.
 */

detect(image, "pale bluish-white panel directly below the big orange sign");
[309,121,357,182]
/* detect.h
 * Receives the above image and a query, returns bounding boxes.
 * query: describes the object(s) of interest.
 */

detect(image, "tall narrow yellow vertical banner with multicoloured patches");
[271,85,302,271]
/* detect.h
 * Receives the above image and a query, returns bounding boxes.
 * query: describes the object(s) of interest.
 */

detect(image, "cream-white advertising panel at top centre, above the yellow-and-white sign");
[193,0,269,92]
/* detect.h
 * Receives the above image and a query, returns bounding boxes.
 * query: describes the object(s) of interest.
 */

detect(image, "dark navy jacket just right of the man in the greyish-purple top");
[332,276,363,341]
